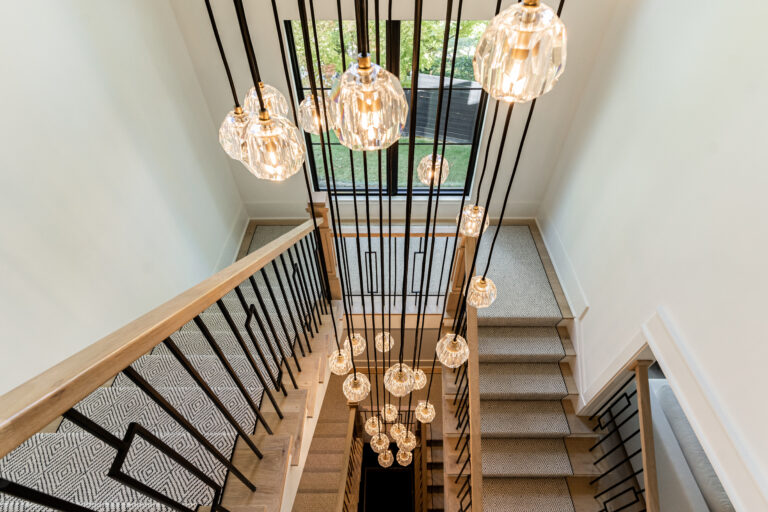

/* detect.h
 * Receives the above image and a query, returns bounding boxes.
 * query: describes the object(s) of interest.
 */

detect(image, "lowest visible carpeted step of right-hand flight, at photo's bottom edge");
[483,478,575,512]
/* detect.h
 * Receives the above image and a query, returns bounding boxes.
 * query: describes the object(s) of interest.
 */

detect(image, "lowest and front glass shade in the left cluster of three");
[243,116,305,181]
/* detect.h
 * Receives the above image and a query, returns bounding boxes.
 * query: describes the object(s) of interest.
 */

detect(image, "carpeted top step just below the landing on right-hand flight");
[478,327,565,362]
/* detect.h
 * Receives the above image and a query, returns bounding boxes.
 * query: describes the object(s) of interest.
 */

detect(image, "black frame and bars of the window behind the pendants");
[284,20,488,197]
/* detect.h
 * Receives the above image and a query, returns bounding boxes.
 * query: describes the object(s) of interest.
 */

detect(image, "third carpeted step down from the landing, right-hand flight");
[480,400,570,438]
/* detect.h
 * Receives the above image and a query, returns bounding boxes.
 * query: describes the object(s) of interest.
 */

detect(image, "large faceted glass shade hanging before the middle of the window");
[330,58,408,151]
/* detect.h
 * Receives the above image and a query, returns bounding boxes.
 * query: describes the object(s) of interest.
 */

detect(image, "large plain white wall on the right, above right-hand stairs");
[539,0,768,511]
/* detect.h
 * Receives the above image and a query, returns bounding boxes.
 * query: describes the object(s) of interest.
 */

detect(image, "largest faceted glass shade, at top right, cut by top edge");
[472,0,567,102]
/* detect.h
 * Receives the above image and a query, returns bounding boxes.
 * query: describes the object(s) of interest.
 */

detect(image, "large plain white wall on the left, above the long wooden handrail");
[0,0,245,393]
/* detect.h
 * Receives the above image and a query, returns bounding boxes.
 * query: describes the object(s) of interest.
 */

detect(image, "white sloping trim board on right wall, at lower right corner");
[642,306,768,512]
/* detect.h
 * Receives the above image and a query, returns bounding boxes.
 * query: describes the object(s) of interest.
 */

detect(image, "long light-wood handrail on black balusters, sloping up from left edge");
[0,219,322,457]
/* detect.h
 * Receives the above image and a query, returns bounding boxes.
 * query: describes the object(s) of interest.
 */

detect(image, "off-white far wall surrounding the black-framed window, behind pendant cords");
[171,0,613,218]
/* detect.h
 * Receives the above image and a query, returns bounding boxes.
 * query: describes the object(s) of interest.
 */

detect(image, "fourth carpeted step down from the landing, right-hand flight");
[481,439,573,478]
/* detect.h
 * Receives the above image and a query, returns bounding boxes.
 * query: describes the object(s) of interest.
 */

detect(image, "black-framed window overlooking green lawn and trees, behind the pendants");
[286,20,487,195]
